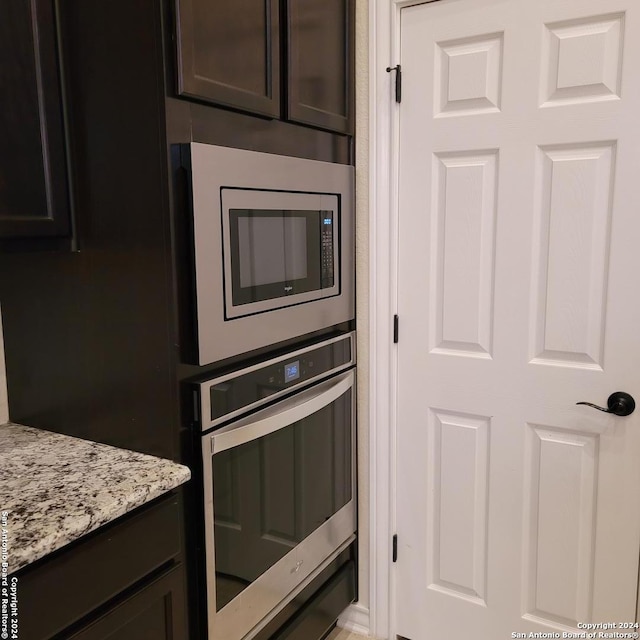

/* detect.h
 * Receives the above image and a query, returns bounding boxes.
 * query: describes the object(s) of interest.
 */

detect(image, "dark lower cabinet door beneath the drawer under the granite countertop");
[69,566,187,640]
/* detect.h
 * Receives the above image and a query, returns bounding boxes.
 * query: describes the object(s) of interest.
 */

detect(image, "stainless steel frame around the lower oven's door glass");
[202,371,356,640]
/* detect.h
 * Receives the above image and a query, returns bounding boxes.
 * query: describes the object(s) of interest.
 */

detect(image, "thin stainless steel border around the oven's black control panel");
[197,331,356,431]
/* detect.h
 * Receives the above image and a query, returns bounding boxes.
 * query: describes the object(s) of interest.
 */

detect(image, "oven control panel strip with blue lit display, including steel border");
[198,333,355,430]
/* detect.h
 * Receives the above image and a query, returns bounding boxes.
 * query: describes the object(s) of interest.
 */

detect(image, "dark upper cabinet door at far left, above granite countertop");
[0,0,70,239]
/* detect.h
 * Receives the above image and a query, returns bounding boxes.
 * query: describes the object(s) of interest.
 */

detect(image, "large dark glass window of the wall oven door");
[212,390,352,611]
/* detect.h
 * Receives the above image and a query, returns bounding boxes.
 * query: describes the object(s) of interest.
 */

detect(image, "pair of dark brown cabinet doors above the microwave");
[177,0,355,134]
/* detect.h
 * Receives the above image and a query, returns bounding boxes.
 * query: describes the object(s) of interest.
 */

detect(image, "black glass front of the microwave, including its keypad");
[229,209,334,306]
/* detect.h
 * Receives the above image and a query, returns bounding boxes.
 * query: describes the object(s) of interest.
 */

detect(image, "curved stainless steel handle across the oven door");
[210,370,355,455]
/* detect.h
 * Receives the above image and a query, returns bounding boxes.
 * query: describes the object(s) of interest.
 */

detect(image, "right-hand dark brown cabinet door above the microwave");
[287,0,355,134]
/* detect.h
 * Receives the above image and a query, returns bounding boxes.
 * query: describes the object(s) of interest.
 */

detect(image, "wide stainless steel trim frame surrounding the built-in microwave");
[185,142,355,365]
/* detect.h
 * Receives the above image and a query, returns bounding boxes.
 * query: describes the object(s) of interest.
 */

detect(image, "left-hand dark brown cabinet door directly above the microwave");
[177,0,280,117]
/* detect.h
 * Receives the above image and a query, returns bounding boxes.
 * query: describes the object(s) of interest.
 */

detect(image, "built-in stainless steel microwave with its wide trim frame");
[182,143,355,364]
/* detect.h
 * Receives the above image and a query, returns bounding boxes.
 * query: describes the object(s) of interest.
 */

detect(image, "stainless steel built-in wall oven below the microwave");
[196,333,356,640]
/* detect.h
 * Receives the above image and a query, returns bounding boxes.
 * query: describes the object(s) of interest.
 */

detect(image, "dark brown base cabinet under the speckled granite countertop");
[16,492,187,640]
